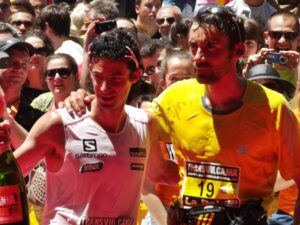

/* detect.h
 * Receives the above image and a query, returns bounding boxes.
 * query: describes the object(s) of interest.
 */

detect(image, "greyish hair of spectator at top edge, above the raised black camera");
[87,0,119,20]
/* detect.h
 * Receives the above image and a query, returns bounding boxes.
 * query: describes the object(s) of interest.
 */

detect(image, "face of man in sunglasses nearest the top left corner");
[10,12,34,37]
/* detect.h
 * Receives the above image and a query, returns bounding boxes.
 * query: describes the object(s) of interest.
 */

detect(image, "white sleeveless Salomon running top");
[42,106,149,225]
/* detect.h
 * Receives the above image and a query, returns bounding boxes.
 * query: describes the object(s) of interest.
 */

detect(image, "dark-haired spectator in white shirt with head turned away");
[39,5,83,65]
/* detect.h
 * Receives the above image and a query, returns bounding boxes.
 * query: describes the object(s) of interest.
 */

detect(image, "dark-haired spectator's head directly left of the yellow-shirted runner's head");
[169,18,192,50]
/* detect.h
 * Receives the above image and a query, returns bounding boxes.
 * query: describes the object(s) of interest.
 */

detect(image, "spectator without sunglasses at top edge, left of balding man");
[135,0,161,38]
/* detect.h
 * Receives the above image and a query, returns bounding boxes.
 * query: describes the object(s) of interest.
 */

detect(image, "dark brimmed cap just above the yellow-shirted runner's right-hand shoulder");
[246,64,295,98]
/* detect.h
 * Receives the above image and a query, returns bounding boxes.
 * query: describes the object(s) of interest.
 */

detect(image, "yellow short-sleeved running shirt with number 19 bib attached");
[151,79,300,208]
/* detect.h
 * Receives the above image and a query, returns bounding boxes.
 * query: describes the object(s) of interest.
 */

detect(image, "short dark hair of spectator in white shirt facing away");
[39,4,71,36]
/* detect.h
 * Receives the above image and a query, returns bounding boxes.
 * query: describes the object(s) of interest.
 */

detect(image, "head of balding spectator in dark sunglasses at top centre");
[156,5,181,39]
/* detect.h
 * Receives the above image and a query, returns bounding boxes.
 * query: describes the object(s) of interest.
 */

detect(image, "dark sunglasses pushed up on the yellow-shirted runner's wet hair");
[196,6,243,41]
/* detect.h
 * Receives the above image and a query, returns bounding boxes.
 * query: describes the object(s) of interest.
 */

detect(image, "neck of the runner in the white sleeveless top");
[90,100,126,133]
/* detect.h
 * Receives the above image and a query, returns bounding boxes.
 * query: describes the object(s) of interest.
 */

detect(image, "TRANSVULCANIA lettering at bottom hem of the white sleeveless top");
[80,217,134,225]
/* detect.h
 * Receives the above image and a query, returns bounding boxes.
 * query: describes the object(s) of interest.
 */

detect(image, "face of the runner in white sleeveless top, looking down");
[90,58,134,109]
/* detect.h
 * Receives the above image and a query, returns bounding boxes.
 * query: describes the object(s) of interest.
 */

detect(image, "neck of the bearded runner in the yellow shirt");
[205,75,247,112]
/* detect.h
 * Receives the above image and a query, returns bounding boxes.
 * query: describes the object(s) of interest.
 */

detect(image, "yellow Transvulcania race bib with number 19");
[181,161,240,207]
